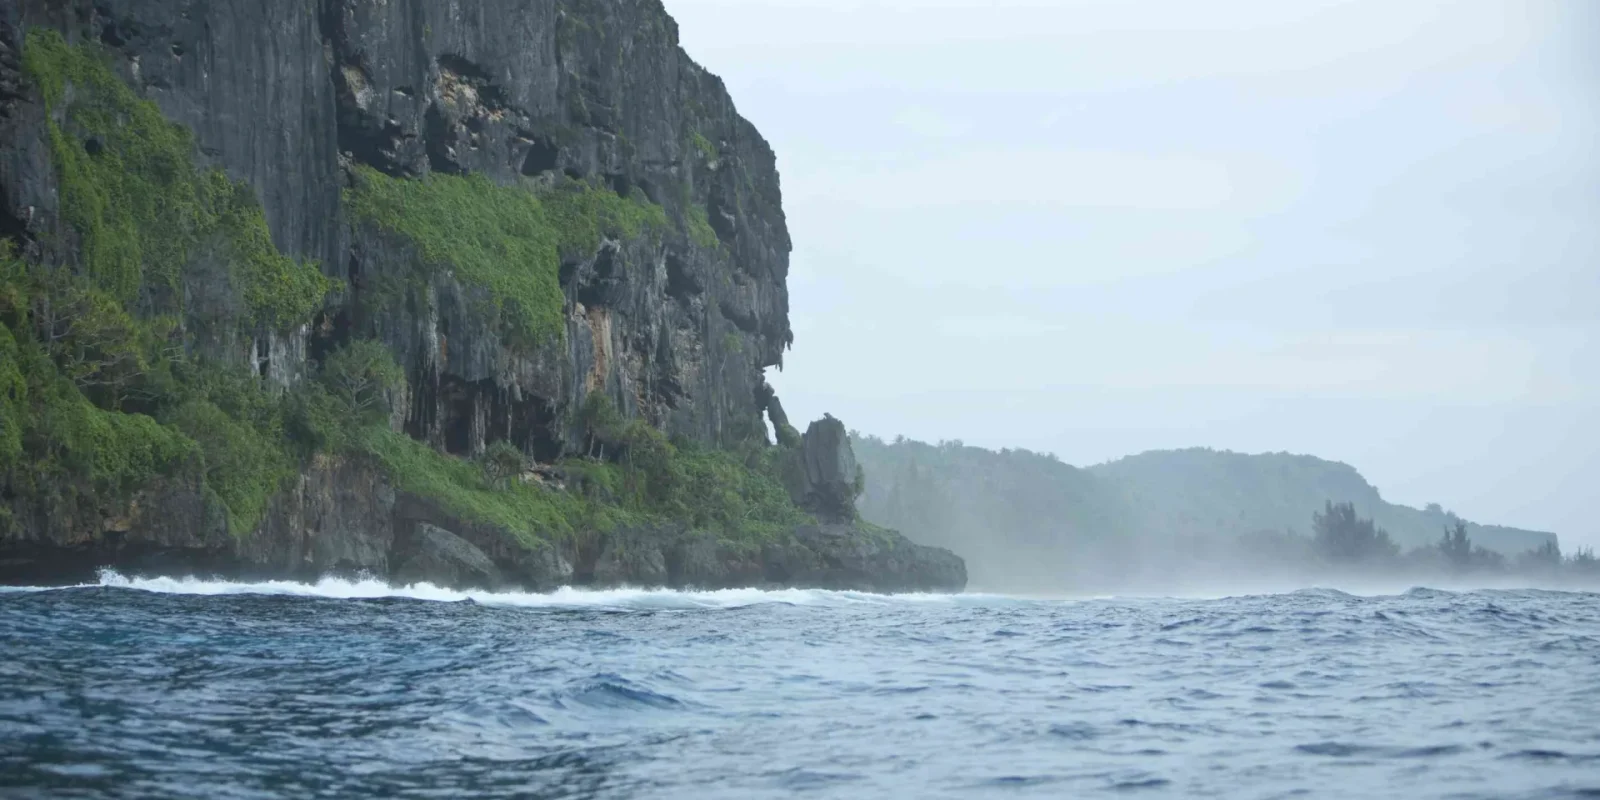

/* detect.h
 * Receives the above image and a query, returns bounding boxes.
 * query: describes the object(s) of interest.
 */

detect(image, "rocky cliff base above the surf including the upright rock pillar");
[0,419,966,594]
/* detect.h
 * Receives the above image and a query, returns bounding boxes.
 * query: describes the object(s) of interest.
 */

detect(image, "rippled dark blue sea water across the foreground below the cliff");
[0,576,1600,800]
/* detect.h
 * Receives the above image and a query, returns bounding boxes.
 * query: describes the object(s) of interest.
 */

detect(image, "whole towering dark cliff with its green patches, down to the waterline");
[0,0,965,589]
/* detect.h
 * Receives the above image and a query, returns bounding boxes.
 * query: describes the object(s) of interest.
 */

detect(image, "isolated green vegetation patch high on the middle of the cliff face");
[347,166,667,341]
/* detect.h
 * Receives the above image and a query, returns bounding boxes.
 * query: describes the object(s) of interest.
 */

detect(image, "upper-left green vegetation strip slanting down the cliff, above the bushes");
[22,27,333,330]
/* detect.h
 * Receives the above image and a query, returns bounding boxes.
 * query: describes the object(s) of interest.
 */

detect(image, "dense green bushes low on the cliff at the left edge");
[0,240,318,534]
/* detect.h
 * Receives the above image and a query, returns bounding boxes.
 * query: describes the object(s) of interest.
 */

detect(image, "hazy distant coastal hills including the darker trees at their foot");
[853,434,1600,594]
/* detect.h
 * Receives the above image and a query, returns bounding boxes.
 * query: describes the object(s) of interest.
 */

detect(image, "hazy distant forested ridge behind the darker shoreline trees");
[854,435,1557,584]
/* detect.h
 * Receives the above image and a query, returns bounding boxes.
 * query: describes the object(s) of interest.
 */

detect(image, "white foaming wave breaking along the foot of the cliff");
[5,570,1016,611]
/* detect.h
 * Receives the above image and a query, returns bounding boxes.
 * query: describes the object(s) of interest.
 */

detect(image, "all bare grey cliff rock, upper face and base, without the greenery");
[0,0,965,589]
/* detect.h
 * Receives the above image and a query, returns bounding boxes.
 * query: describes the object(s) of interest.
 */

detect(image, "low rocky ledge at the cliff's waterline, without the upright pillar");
[0,494,966,594]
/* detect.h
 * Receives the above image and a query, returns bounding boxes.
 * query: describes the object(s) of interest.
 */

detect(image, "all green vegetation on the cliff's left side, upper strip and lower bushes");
[0,29,333,534]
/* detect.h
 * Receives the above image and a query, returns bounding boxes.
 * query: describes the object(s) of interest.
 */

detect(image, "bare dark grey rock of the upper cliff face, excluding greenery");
[9,0,792,453]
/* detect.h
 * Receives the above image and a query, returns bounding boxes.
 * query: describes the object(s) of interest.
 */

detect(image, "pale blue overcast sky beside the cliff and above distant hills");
[666,0,1600,550]
